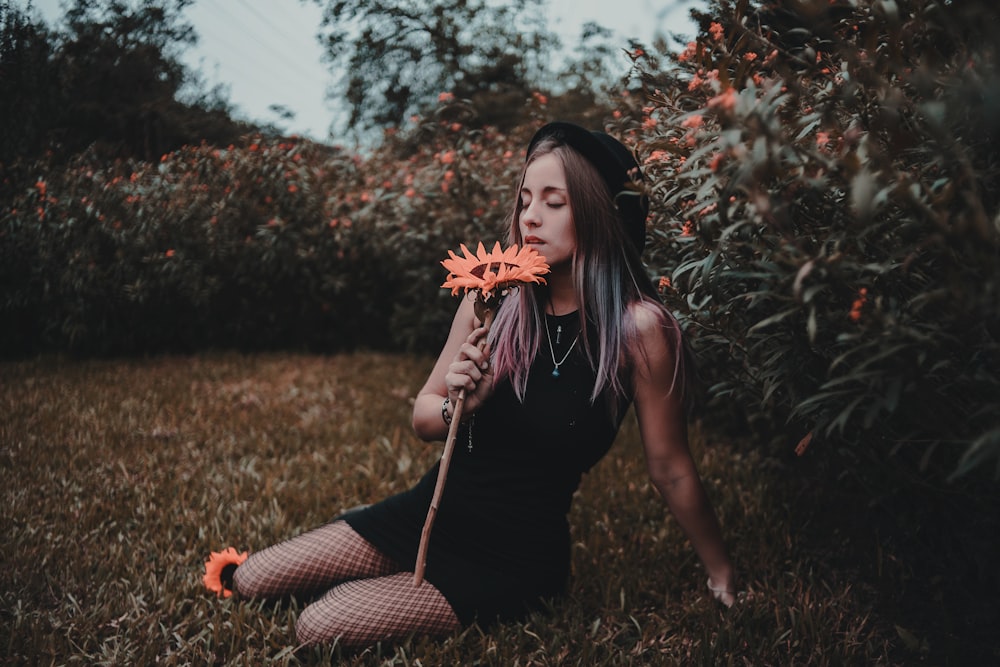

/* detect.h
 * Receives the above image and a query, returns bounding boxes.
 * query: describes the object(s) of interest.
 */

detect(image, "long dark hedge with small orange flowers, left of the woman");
[0,109,520,355]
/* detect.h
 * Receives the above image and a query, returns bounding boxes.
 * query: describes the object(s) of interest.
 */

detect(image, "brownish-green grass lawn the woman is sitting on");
[0,354,1000,665]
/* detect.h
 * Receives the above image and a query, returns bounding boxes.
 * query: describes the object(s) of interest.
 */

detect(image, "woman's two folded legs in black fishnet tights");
[234,521,461,647]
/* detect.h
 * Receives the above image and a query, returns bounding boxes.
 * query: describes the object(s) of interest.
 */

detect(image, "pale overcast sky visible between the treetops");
[25,0,703,141]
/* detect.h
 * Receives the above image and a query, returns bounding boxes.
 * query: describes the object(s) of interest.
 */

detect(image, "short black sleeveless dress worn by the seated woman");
[345,313,627,625]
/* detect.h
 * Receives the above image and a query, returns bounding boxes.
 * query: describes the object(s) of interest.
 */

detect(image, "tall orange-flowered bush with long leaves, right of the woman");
[617,0,1000,480]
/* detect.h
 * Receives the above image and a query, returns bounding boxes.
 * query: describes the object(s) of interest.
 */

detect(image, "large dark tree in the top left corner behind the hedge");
[0,0,256,161]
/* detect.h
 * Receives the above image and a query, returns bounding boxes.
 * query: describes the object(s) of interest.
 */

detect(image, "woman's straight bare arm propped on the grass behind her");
[632,305,736,606]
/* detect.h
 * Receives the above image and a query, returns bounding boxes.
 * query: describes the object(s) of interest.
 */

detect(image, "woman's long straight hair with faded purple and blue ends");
[490,137,690,417]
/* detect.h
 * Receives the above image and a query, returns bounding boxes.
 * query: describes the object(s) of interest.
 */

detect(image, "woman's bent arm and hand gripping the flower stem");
[413,299,493,440]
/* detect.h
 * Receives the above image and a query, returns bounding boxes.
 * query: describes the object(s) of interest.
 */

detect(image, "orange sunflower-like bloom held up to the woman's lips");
[441,241,549,306]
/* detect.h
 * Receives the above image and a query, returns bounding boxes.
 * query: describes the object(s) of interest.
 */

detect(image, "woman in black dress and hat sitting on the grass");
[235,123,734,646]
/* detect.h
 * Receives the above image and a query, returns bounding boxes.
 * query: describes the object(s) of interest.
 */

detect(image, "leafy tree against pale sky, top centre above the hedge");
[316,0,559,136]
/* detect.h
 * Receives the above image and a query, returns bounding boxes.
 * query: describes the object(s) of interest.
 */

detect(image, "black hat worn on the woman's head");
[528,122,649,254]
